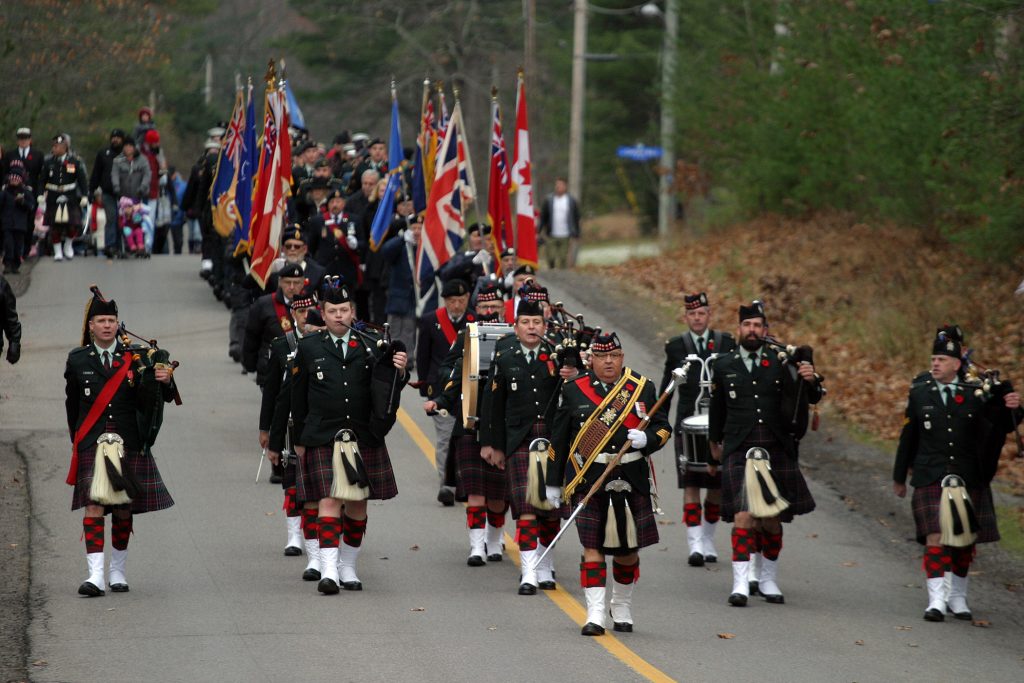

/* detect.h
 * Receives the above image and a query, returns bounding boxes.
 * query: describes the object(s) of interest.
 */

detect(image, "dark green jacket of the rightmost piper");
[893,377,1019,488]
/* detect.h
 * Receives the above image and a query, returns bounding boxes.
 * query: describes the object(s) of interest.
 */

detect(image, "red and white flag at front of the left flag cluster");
[249,79,292,288]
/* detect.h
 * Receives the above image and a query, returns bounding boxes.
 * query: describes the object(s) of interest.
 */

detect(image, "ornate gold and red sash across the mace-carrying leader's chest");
[565,368,647,499]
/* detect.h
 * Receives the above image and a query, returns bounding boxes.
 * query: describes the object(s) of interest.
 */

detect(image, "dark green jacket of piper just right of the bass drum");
[480,335,562,455]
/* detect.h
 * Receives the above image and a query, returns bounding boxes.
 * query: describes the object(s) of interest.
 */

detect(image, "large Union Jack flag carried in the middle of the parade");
[416,102,465,303]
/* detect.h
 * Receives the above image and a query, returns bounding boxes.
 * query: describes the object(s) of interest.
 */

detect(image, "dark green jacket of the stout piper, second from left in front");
[292,330,393,446]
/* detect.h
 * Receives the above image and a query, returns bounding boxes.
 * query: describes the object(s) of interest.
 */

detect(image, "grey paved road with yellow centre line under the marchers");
[8,257,1024,682]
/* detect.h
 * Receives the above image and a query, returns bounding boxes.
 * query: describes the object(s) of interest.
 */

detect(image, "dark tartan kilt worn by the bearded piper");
[721,425,814,523]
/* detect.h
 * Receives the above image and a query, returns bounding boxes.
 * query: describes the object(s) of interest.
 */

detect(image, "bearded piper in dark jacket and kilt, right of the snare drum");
[708,301,822,607]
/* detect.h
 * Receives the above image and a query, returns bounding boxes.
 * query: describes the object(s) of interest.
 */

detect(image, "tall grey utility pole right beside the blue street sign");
[657,0,679,243]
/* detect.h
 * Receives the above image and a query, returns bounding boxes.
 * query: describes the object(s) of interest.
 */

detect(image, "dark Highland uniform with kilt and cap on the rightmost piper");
[893,328,1020,622]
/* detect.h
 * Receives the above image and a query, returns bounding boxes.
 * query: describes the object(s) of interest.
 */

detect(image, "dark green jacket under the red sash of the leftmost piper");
[65,342,174,451]
